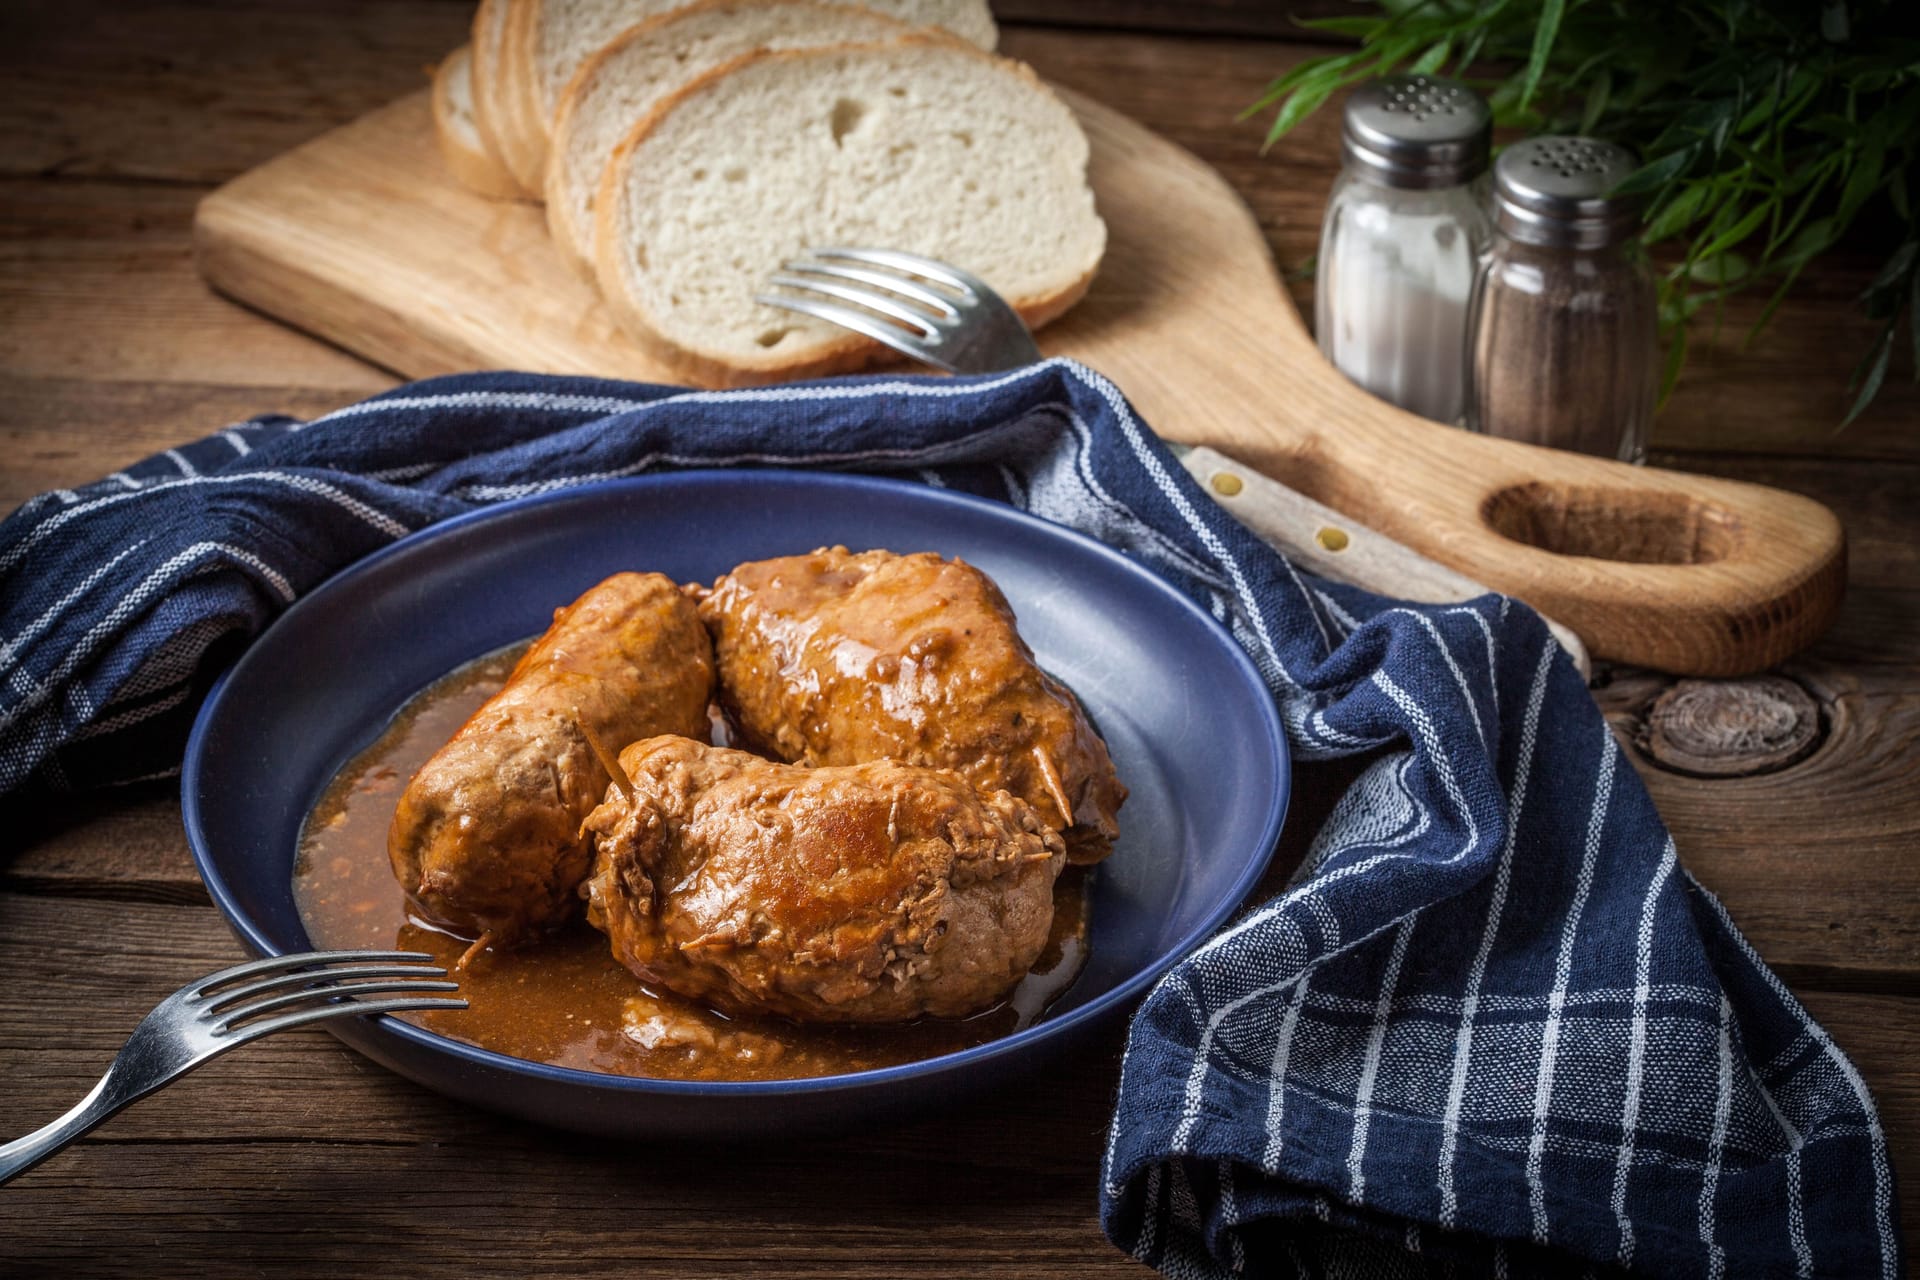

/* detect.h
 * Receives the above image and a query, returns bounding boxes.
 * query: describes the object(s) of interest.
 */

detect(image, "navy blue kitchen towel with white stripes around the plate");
[0,361,1901,1276]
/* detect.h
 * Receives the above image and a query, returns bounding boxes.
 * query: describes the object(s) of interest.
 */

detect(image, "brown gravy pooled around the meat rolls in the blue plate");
[294,645,1087,1080]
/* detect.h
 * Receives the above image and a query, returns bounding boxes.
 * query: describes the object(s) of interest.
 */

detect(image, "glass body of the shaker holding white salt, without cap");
[1313,171,1492,422]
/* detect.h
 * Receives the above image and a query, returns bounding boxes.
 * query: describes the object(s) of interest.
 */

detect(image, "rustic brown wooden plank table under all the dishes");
[0,0,1920,1276]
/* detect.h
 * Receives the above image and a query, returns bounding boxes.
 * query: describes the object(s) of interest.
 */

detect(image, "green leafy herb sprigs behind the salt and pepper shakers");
[1248,0,1920,424]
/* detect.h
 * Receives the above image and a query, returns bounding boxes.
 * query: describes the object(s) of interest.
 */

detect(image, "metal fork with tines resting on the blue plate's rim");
[0,952,467,1182]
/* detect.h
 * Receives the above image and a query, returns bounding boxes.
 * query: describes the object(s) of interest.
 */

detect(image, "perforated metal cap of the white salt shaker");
[1340,75,1494,190]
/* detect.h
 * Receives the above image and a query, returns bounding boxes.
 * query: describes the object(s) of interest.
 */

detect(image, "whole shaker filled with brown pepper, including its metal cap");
[1469,138,1659,462]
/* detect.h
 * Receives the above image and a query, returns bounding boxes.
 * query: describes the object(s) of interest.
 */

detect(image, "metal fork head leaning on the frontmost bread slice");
[756,248,1041,374]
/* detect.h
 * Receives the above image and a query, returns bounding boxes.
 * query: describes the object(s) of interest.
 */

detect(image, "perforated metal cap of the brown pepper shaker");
[1494,138,1642,249]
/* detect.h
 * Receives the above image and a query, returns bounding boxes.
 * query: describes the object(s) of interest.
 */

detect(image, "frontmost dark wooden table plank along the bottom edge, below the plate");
[0,1143,1152,1280]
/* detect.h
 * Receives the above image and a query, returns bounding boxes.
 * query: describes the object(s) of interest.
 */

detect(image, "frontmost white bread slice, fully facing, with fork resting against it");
[595,36,1106,386]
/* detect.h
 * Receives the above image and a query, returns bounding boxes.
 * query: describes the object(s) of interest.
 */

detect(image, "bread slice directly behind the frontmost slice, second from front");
[547,0,929,276]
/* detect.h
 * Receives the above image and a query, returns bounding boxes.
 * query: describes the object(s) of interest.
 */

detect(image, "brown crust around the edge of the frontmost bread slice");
[593,40,1104,388]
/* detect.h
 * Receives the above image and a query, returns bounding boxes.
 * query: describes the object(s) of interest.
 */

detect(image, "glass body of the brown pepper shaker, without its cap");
[1471,232,1659,462]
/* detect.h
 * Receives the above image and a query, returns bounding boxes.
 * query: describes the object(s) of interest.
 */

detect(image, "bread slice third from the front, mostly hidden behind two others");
[503,0,998,205]
